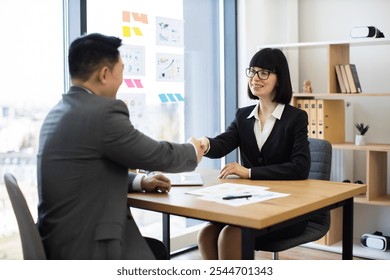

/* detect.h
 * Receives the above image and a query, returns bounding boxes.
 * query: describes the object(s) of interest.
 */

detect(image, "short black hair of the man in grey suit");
[68,33,122,81]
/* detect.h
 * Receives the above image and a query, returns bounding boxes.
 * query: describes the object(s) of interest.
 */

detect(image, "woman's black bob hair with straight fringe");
[248,48,292,104]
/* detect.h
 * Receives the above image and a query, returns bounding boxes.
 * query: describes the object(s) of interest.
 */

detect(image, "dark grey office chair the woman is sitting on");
[256,138,332,260]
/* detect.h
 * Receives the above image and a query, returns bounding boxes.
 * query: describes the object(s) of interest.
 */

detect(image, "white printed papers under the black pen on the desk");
[187,183,289,206]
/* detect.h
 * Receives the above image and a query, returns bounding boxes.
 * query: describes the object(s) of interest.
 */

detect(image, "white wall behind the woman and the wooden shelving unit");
[238,0,390,252]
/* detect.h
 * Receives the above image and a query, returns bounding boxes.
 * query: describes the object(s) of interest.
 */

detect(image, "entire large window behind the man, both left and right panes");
[0,0,236,259]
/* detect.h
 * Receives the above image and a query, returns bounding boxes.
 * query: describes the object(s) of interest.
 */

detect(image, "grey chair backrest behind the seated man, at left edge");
[4,173,46,260]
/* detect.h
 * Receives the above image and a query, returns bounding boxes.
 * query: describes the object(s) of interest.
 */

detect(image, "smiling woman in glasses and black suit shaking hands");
[198,48,310,259]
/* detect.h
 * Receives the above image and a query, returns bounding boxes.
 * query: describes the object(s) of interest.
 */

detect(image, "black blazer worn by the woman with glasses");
[205,105,310,180]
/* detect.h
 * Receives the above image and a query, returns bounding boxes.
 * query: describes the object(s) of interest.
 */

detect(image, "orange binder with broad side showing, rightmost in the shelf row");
[317,99,345,144]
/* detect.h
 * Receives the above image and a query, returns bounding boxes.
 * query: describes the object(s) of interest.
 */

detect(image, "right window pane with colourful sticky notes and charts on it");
[86,0,236,250]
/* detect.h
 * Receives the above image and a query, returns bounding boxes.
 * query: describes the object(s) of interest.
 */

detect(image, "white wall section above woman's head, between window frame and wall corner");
[237,0,298,107]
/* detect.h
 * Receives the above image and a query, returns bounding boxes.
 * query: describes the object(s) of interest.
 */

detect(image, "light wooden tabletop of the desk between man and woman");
[128,169,367,229]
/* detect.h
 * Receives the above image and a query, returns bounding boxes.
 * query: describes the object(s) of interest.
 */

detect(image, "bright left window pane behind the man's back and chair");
[0,0,64,259]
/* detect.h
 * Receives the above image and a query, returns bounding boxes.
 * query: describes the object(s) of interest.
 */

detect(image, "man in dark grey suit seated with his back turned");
[37,34,203,259]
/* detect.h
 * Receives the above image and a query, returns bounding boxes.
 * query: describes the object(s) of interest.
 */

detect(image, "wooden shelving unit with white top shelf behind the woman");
[257,38,390,257]
